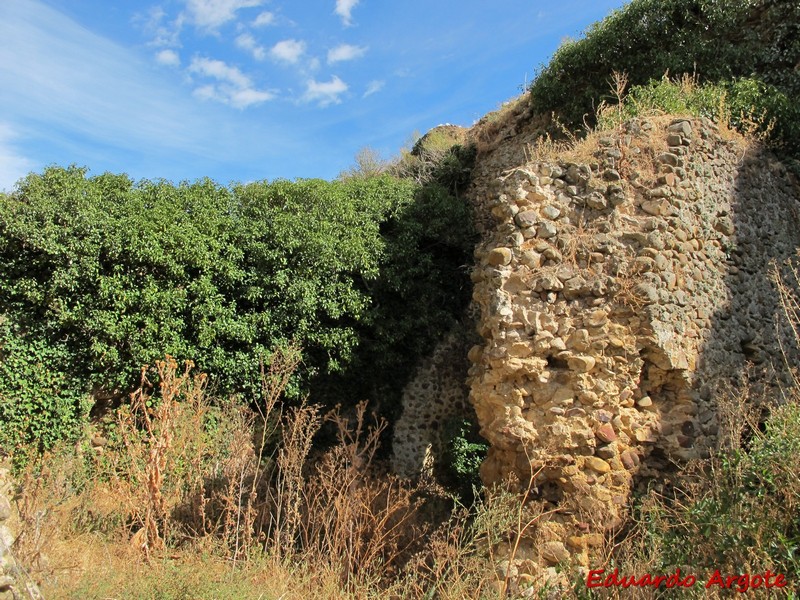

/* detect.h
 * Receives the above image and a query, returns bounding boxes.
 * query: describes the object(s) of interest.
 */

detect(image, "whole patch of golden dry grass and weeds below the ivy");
[7,351,536,599]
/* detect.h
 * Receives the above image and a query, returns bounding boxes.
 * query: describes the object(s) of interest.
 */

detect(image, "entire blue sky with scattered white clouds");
[0,0,623,190]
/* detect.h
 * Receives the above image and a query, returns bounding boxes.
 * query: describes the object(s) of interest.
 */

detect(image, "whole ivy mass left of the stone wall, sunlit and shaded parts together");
[0,167,471,450]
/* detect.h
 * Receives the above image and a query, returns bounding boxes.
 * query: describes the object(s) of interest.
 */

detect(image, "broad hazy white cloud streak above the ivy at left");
[0,0,308,188]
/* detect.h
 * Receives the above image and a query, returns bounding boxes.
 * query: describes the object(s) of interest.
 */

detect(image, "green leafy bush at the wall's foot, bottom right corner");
[619,400,800,581]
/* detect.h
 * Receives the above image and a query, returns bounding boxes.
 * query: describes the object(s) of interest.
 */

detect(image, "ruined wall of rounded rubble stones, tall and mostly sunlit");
[468,118,800,564]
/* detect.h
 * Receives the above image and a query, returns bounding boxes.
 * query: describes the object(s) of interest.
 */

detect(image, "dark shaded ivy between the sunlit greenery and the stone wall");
[314,141,476,421]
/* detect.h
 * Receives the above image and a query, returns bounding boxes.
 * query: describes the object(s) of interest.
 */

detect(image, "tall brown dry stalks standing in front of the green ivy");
[10,350,552,598]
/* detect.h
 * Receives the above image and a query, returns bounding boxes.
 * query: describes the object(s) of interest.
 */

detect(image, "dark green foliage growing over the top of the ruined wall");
[530,0,800,156]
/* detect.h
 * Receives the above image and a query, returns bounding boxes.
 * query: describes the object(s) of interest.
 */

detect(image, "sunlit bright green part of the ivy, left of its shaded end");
[0,168,378,389]
